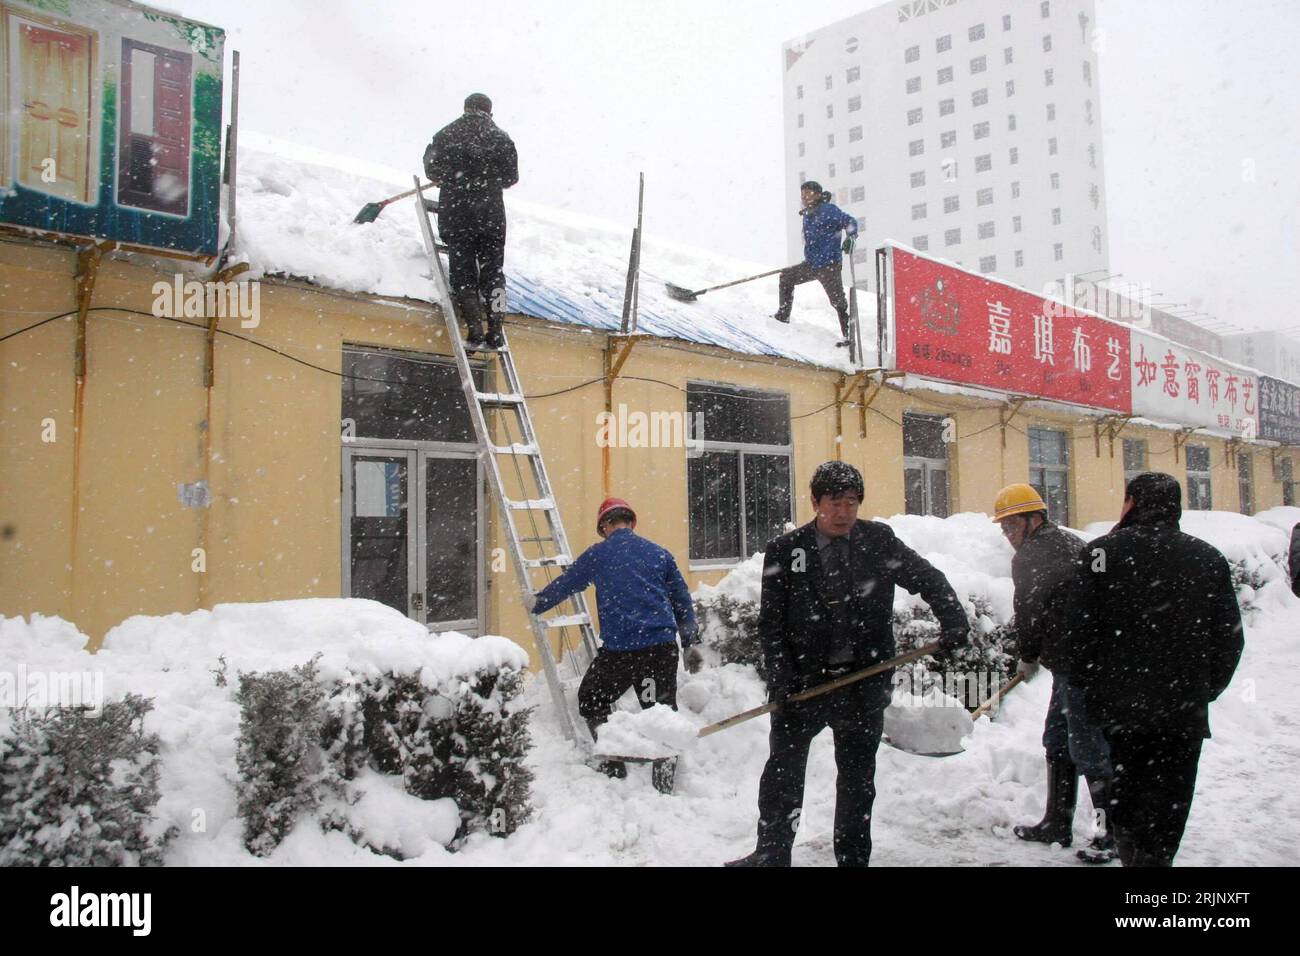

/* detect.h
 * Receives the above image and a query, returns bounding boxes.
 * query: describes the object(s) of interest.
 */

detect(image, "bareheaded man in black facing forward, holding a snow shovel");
[727,462,970,866]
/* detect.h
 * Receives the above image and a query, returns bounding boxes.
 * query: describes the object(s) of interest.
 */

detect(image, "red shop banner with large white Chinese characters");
[891,248,1131,412]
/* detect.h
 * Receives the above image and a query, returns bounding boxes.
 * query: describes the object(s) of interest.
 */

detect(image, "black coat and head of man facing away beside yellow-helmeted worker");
[1070,473,1243,737]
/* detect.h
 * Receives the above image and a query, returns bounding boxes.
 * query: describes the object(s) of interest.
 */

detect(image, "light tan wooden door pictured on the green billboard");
[0,9,95,203]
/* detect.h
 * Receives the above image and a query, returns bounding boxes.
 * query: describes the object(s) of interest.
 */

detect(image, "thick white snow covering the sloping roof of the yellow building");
[237,130,875,371]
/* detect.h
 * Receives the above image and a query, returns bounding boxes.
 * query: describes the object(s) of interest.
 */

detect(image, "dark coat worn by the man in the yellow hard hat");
[1011,520,1083,674]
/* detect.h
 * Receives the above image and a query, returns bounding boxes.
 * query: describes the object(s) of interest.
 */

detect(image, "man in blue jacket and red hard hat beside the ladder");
[532,498,705,792]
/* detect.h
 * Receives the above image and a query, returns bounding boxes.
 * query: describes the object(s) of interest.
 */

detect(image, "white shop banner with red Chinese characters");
[1131,329,1262,440]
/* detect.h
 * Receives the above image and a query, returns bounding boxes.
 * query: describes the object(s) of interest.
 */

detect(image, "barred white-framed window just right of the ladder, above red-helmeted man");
[686,382,793,562]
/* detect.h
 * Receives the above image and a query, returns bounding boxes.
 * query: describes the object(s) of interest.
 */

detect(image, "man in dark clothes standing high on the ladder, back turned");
[424,92,519,349]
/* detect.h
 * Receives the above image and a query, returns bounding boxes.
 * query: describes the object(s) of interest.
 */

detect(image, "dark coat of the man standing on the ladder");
[424,111,519,230]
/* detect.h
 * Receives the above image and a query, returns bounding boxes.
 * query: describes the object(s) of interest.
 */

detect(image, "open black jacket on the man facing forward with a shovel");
[758,520,970,709]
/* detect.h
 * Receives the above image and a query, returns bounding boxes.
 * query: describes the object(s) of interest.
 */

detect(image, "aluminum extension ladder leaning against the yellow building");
[415,178,597,745]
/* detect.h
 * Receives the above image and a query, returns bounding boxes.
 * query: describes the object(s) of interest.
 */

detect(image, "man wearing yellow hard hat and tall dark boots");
[993,484,1115,862]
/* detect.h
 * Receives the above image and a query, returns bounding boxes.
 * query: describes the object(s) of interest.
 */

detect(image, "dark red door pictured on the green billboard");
[117,39,192,216]
